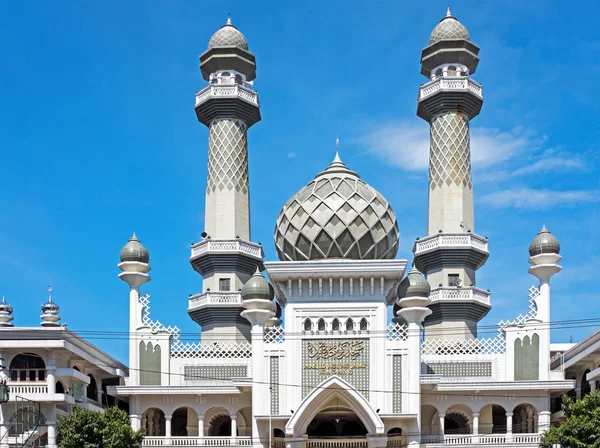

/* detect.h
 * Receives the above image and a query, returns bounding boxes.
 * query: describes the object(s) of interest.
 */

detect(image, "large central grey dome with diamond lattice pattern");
[275,154,400,261]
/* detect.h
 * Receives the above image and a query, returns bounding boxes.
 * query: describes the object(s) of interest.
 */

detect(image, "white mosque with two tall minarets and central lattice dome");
[0,9,600,448]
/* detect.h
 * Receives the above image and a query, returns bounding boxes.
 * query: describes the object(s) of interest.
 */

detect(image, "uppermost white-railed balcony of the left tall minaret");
[194,84,261,127]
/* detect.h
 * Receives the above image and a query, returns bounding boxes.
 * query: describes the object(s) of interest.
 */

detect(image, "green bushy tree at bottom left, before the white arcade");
[58,406,144,448]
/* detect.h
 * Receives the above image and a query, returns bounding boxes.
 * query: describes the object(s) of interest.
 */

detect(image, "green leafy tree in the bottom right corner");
[540,390,600,448]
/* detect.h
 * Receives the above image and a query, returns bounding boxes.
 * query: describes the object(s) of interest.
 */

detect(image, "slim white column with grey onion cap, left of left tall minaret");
[118,233,151,386]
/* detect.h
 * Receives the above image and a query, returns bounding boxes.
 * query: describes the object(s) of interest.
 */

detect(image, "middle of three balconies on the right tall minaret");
[413,233,489,274]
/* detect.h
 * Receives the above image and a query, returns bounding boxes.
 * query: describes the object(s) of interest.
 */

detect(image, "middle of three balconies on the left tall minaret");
[190,238,264,276]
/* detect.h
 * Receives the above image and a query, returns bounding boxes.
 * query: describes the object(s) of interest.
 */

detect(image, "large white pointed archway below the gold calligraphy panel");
[285,376,384,437]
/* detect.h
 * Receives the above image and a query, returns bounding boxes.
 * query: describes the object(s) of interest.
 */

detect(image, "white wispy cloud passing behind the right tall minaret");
[358,121,545,171]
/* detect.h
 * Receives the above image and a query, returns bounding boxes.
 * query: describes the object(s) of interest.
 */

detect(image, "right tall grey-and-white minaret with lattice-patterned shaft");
[413,8,490,339]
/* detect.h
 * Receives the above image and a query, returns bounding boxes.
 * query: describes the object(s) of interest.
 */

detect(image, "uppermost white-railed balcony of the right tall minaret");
[417,76,483,121]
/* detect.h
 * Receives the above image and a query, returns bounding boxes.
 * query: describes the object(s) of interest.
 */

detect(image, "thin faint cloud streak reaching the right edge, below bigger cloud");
[482,188,600,209]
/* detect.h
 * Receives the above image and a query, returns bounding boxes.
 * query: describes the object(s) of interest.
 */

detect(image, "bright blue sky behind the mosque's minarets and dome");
[0,0,600,360]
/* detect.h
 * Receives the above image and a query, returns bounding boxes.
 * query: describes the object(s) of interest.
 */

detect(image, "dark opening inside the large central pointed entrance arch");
[306,398,367,438]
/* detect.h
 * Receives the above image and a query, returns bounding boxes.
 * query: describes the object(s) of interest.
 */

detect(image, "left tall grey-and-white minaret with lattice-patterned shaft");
[188,14,264,342]
